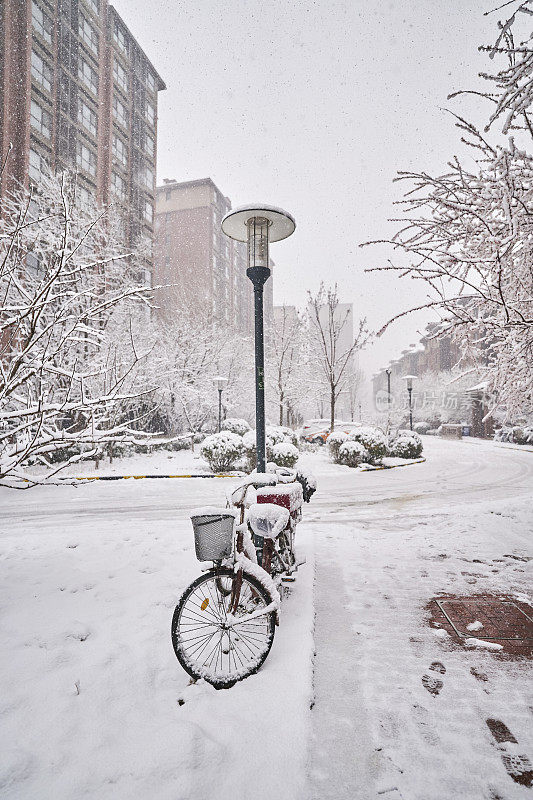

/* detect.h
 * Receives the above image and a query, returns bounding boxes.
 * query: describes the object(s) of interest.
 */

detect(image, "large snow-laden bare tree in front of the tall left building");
[0,173,154,487]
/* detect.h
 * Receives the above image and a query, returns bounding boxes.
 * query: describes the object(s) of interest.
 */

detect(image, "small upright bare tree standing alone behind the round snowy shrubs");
[308,283,370,430]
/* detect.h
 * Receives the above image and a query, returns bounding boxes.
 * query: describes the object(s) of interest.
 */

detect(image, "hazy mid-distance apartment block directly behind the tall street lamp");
[154,178,273,335]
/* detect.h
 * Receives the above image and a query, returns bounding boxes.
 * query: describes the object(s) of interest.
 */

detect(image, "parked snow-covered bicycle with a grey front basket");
[171,469,315,689]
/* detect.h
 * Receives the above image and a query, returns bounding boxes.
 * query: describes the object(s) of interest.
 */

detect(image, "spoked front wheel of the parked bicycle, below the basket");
[171,567,276,689]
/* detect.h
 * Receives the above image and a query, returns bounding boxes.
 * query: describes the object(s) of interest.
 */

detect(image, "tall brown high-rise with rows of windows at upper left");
[0,0,165,279]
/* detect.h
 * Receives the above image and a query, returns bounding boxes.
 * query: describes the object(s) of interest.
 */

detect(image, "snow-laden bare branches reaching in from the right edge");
[362,3,533,416]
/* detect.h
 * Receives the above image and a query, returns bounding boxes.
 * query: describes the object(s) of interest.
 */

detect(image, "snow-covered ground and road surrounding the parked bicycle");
[0,437,533,800]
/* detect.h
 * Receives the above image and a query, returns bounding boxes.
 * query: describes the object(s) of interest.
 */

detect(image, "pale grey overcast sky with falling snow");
[114,0,498,373]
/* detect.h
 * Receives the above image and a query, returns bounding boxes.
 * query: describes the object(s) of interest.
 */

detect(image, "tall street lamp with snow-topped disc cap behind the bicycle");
[222,204,296,472]
